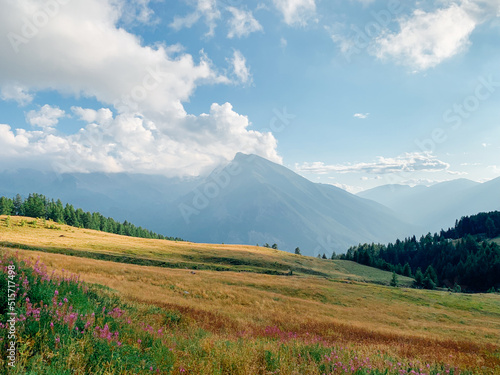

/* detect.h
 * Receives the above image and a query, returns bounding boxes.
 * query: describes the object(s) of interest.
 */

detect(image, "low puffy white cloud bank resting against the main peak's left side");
[0,103,282,176]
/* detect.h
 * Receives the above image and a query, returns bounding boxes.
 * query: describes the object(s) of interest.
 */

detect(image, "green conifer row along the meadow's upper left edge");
[0,193,183,241]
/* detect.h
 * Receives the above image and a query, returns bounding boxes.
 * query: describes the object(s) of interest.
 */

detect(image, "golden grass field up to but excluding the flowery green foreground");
[0,216,500,373]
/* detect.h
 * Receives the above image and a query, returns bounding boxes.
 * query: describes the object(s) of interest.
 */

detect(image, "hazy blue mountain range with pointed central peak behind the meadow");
[0,153,500,255]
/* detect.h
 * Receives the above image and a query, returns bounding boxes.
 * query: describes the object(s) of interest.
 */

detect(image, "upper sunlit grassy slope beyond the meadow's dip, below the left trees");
[0,216,412,285]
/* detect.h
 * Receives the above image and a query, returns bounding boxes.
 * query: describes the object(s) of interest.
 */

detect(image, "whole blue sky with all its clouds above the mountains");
[0,0,500,193]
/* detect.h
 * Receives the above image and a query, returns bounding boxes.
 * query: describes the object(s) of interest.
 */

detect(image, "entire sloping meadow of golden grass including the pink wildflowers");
[0,216,500,375]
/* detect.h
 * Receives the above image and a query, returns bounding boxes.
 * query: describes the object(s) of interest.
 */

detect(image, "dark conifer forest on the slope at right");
[341,211,500,292]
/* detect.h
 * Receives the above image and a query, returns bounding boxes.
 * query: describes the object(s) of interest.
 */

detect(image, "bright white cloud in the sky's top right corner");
[375,0,498,71]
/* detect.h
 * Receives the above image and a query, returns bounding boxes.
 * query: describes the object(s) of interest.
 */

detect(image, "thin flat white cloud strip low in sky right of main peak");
[295,152,450,174]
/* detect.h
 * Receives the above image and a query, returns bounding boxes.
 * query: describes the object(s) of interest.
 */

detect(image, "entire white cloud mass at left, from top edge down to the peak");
[0,0,281,175]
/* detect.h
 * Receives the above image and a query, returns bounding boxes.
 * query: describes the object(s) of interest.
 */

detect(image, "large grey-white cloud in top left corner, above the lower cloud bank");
[0,0,226,117]
